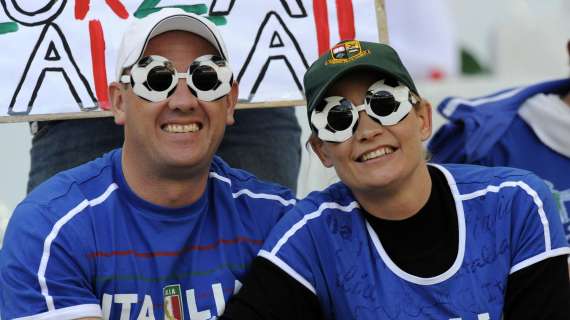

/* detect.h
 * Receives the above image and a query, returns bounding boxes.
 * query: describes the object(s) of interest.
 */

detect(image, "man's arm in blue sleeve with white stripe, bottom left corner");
[0,202,102,319]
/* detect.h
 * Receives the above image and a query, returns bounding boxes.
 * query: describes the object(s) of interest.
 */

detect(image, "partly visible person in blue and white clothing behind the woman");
[428,41,570,249]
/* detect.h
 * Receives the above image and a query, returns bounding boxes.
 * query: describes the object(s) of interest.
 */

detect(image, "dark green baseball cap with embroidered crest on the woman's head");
[303,40,419,119]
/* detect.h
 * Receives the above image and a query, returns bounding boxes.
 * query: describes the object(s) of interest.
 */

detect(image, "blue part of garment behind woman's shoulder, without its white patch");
[428,79,570,243]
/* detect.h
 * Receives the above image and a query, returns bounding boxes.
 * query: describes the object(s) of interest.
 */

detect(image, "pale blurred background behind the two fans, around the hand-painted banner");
[0,0,570,247]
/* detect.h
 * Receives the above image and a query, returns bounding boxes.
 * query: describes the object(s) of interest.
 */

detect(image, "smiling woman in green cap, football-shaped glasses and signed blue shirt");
[219,41,570,320]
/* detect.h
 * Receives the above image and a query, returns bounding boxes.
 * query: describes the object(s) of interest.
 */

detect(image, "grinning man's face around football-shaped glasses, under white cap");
[111,31,237,179]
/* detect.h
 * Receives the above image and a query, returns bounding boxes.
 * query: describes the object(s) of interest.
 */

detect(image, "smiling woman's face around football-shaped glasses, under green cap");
[311,71,431,193]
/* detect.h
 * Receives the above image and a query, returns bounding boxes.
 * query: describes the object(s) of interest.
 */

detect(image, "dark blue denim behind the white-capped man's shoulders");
[28,108,301,192]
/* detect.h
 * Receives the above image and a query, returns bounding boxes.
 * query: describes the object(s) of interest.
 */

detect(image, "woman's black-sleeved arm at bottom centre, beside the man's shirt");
[220,257,324,320]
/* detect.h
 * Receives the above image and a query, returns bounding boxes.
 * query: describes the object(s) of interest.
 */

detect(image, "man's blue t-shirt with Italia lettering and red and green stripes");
[0,149,295,320]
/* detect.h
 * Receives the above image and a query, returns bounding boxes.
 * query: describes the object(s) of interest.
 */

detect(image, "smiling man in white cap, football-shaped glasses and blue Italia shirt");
[0,9,295,319]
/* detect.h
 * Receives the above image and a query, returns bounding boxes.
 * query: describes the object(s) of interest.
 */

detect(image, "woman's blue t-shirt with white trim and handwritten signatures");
[259,165,570,320]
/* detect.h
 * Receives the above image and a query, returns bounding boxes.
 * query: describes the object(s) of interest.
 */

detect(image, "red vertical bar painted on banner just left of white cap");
[89,20,111,110]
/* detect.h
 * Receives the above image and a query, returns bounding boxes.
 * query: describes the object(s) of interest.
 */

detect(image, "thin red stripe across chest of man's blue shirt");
[87,237,263,258]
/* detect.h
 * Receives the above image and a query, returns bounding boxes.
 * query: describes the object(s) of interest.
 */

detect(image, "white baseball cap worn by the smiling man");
[115,8,229,81]
